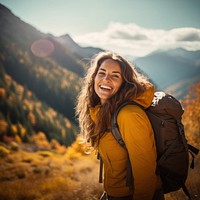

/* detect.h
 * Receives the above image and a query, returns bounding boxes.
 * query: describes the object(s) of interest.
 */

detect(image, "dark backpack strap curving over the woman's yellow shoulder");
[111,100,144,148]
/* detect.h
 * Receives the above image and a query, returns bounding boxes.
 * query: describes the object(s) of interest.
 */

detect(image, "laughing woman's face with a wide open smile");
[94,59,123,104]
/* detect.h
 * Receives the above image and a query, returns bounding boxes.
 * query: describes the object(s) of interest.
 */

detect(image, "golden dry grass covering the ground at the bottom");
[0,141,200,200]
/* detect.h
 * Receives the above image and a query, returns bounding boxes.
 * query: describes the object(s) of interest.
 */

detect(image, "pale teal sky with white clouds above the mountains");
[0,0,200,57]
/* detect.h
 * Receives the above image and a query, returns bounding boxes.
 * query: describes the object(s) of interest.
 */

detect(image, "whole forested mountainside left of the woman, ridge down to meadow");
[0,5,85,145]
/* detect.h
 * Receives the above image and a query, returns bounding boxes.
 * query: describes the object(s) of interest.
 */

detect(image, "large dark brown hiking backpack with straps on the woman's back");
[111,92,199,198]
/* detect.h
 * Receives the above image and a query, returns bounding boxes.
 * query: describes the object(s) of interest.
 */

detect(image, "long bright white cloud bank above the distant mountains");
[74,22,200,57]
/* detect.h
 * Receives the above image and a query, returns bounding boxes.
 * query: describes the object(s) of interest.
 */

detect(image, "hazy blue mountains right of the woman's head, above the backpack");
[135,48,200,99]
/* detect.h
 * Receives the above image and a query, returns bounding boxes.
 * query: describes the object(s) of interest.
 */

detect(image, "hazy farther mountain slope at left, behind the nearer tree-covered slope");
[0,6,84,121]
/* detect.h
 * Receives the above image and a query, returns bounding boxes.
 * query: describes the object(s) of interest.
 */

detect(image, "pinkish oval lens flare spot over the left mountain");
[31,39,54,58]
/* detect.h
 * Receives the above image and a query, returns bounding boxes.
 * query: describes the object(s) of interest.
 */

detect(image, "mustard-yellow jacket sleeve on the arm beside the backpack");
[117,105,158,200]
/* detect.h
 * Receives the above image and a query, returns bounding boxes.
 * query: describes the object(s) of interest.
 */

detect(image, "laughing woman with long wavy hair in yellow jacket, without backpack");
[76,52,164,200]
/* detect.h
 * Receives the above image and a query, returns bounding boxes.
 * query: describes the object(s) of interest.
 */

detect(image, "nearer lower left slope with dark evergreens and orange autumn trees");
[0,65,78,145]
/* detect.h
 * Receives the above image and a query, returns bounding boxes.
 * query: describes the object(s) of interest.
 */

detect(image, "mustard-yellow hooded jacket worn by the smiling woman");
[91,87,160,200]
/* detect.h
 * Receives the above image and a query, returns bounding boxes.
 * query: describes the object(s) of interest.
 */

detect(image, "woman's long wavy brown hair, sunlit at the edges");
[76,52,150,146]
